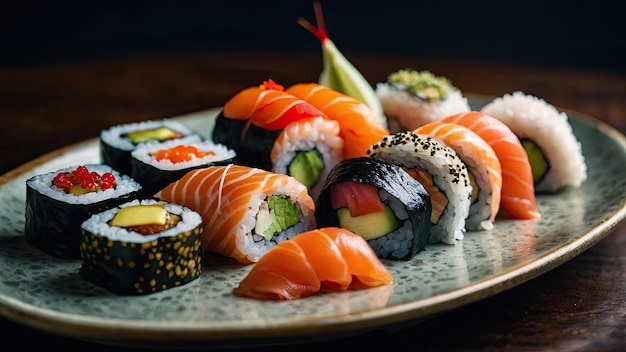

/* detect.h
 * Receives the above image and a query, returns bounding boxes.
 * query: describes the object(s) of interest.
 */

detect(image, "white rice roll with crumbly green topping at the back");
[376,68,470,133]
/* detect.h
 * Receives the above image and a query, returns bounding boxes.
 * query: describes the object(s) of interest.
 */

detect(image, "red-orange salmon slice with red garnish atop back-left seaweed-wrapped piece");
[222,79,324,131]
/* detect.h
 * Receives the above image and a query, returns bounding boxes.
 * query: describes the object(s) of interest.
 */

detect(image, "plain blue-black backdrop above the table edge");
[0,0,626,73]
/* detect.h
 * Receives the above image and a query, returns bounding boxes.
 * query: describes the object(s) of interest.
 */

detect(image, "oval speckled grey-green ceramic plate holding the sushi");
[0,95,626,348]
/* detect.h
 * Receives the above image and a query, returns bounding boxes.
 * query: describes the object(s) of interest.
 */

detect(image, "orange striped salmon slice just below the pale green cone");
[285,83,389,159]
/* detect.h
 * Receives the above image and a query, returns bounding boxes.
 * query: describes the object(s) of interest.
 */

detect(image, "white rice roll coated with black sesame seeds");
[368,131,472,244]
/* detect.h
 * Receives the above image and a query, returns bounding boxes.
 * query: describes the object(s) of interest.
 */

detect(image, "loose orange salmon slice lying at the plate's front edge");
[233,227,393,300]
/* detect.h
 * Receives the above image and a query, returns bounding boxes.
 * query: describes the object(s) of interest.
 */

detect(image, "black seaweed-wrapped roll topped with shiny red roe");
[24,164,141,259]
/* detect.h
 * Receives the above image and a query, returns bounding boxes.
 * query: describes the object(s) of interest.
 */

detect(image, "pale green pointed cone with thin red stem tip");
[298,1,387,126]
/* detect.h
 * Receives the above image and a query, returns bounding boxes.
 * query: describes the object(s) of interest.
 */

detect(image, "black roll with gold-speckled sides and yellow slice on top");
[80,199,202,295]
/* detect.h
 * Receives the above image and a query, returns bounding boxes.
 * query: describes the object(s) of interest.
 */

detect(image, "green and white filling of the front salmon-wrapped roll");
[254,195,300,241]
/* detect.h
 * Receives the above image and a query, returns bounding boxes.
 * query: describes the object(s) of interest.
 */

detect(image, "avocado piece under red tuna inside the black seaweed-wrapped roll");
[337,206,399,240]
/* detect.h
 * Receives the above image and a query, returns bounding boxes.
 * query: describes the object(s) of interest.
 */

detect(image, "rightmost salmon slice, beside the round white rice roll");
[441,111,541,219]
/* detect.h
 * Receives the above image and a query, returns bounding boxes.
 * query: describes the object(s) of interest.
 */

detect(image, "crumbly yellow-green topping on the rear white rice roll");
[387,68,453,100]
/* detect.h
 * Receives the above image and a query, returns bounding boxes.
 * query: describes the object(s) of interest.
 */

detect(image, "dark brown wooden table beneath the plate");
[0,52,626,351]
